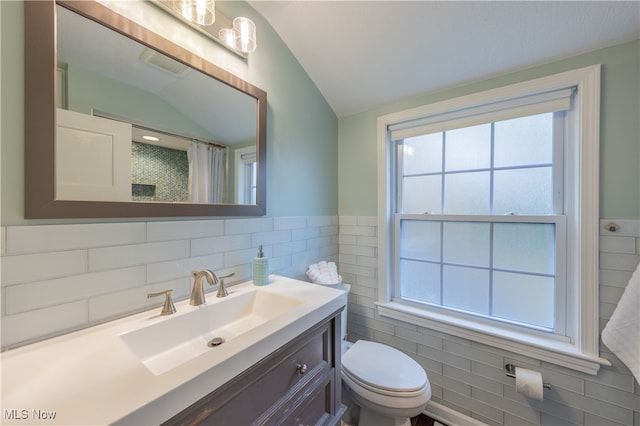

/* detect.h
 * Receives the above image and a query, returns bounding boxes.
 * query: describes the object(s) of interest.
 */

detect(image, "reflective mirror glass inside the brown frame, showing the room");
[55,6,257,204]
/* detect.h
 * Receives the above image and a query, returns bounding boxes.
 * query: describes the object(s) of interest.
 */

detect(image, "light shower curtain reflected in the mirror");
[187,141,226,203]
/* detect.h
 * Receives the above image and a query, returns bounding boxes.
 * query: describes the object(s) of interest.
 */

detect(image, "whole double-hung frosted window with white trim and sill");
[378,66,607,374]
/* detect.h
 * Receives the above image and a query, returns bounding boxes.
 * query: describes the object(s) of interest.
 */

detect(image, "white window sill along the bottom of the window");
[376,302,611,375]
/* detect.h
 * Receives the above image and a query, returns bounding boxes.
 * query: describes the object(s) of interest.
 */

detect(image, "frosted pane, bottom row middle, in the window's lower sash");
[442,266,491,315]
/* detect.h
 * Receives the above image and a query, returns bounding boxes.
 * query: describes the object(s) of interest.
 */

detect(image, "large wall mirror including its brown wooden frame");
[24,0,266,218]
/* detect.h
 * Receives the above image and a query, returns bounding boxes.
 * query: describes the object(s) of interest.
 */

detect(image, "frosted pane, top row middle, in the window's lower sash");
[442,222,490,267]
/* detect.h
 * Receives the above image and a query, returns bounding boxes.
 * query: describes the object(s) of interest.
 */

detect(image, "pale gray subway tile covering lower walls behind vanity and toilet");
[0,216,640,426]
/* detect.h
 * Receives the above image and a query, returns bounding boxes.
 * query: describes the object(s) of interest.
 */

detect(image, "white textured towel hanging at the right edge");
[602,265,640,383]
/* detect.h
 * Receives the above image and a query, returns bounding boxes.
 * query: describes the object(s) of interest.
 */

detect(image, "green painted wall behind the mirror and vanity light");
[0,1,338,225]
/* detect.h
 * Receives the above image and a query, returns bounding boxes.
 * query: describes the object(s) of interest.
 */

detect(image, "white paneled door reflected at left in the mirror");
[56,109,131,201]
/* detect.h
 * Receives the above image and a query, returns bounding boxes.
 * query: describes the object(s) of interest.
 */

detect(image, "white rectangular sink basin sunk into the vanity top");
[119,286,303,375]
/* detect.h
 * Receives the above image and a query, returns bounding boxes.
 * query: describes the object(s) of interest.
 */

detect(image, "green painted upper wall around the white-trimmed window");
[338,41,640,219]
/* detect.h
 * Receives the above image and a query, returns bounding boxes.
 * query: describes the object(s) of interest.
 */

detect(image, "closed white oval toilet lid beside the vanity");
[342,340,427,392]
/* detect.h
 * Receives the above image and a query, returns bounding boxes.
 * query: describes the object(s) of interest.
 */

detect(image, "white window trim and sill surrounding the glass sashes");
[376,65,610,375]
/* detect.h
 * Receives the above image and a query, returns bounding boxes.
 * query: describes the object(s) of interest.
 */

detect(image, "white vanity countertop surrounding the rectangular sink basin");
[0,275,346,425]
